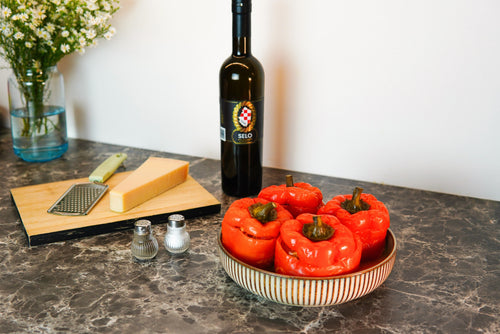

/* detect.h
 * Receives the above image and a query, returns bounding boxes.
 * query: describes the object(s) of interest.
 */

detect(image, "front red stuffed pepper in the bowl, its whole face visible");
[274,214,362,277]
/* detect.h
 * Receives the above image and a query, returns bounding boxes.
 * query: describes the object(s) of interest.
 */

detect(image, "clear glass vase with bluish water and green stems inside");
[8,66,68,162]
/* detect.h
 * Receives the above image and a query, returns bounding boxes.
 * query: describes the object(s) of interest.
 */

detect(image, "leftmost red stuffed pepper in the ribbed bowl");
[221,198,293,269]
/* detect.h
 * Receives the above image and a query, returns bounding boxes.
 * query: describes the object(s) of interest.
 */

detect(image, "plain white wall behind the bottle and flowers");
[0,0,500,200]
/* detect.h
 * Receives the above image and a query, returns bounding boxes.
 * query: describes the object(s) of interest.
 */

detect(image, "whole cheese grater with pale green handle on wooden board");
[47,153,127,216]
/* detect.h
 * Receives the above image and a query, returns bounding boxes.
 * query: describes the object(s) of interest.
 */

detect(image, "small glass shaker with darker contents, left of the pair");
[130,219,158,260]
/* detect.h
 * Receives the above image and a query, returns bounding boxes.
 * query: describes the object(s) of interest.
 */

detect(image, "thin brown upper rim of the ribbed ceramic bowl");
[217,228,397,281]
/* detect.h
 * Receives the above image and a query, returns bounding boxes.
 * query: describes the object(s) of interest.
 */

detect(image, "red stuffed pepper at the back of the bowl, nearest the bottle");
[258,175,323,217]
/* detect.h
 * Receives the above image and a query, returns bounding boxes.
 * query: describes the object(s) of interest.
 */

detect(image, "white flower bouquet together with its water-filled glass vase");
[0,0,119,161]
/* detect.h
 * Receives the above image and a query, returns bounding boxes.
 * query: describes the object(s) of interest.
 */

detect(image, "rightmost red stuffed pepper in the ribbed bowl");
[318,187,390,261]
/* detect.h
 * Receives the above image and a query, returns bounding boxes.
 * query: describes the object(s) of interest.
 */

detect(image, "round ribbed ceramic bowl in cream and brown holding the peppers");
[219,229,396,306]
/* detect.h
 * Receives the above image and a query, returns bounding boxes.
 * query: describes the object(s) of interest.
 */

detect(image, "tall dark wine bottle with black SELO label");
[219,0,264,197]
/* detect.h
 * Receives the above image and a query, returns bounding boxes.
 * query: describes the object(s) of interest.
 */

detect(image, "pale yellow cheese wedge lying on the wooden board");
[109,157,189,212]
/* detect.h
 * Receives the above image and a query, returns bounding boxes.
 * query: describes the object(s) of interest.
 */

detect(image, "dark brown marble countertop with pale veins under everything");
[0,126,500,333]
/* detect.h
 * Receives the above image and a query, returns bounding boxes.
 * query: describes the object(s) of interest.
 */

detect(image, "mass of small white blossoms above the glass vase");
[0,0,119,77]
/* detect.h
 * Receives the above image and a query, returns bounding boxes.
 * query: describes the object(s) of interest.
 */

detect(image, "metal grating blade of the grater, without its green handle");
[47,183,108,216]
